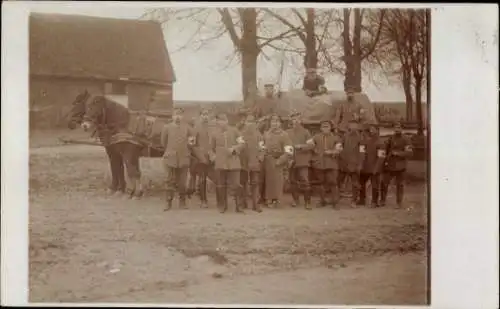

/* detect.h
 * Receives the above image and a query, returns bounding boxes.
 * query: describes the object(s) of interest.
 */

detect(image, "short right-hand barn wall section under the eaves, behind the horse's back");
[127,84,173,111]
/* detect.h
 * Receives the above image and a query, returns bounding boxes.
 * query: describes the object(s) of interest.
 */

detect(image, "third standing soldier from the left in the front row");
[209,114,244,213]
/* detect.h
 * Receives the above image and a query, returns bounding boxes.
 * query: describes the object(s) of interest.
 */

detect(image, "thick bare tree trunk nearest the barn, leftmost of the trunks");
[240,8,259,101]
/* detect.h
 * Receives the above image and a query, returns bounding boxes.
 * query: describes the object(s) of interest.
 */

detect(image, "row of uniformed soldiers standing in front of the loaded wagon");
[161,71,412,212]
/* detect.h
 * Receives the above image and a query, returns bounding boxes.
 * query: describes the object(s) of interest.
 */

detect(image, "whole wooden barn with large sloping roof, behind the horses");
[29,14,175,129]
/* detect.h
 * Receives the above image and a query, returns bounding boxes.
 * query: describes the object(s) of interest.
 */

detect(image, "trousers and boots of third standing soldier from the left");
[215,169,241,211]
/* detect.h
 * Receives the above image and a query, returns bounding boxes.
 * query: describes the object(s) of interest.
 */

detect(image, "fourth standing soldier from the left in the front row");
[240,115,264,212]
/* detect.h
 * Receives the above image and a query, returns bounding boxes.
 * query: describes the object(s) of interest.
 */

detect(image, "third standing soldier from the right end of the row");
[339,120,366,207]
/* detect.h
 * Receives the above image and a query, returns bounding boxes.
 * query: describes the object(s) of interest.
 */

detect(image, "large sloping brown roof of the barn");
[29,13,175,83]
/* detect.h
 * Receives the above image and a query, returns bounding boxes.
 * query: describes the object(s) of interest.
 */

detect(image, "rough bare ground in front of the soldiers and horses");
[29,146,427,305]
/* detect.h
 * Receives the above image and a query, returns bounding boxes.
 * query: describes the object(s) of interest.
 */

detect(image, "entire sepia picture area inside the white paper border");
[2,2,498,306]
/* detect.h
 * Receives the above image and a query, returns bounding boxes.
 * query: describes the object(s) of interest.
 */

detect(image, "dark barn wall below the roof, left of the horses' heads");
[29,77,104,130]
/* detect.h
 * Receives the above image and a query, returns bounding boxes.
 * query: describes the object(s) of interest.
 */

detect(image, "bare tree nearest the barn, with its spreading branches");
[144,8,297,100]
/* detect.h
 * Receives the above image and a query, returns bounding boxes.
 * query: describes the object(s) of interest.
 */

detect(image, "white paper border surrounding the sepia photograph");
[1,1,499,308]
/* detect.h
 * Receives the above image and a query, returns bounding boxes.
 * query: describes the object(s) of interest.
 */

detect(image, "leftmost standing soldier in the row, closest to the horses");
[161,108,194,210]
